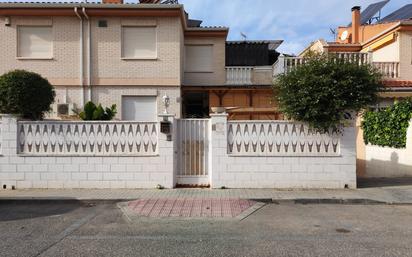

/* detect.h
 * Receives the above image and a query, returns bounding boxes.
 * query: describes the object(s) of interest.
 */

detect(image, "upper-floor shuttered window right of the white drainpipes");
[122,27,157,59]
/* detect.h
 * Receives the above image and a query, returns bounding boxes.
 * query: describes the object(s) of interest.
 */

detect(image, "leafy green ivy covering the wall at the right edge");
[362,99,412,148]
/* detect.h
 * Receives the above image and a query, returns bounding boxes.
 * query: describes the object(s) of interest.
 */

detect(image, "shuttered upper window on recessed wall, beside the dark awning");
[185,45,213,72]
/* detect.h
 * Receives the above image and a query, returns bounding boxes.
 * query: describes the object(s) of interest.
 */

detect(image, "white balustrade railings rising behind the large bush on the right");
[273,53,399,79]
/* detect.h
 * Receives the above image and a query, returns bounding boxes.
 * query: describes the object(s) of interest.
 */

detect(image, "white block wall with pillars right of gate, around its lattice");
[210,115,356,188]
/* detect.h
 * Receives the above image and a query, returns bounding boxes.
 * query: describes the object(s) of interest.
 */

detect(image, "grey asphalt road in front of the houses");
[0,202,412,257]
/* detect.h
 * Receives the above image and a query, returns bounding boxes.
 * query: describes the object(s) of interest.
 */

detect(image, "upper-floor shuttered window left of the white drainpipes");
[17,26,53,58]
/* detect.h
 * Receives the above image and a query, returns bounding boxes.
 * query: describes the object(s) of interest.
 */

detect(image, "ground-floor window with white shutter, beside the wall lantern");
[122,96,157,121]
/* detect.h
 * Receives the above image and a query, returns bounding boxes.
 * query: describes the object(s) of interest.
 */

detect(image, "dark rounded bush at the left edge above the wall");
[0,70,56,120]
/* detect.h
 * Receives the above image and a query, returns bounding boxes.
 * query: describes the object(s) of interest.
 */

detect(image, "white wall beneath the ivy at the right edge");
[365,122,412,178]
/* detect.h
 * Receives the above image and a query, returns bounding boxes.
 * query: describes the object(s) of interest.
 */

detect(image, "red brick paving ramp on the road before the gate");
[128,198,256,218]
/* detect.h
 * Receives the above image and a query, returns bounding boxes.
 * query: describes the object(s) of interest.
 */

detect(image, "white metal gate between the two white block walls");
[176,119,209,185]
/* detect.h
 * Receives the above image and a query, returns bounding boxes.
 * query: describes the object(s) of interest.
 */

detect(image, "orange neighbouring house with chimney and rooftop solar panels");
[300,1,412,99]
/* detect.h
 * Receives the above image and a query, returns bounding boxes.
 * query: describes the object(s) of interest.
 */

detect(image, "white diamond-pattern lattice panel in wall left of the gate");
[18,121,158,155]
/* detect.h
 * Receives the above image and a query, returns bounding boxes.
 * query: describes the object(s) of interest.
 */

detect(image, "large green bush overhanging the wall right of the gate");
[274,55,383,131]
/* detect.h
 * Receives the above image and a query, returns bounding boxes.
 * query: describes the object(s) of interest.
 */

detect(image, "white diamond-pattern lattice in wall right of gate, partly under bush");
[228,121,340,156]
